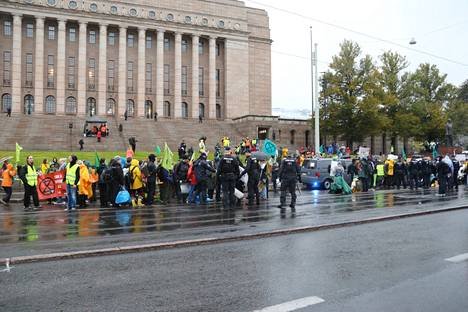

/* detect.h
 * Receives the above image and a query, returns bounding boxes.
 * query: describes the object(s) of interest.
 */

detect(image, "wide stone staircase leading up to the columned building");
[0,114,246,151]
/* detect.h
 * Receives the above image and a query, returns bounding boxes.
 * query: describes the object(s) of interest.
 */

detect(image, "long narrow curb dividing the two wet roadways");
[0,205,468,265]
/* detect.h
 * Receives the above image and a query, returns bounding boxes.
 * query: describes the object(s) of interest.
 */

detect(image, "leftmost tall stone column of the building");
[11,14,23,113]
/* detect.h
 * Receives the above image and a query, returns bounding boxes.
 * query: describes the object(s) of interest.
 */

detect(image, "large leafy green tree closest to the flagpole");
[321,40,385,146]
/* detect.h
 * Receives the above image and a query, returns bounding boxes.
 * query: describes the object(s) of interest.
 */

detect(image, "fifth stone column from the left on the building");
[97,23,108,116]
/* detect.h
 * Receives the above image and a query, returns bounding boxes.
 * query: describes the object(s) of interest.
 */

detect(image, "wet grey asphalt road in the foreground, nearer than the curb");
[0,210,468,312]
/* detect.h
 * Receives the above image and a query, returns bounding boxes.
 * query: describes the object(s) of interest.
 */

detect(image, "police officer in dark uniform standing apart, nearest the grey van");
[278,155,301,213]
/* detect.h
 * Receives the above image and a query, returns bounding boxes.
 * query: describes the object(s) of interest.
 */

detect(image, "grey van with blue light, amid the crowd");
[301,158,352,190]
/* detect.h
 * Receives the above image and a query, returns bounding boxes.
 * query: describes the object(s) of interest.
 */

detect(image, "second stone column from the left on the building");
[34,16,44,112]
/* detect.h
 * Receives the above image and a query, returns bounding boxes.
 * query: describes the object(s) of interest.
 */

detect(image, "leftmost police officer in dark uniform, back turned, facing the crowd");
[216,147,240,208]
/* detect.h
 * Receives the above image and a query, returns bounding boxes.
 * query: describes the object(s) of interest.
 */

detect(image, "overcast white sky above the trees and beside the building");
[245,0,468,109]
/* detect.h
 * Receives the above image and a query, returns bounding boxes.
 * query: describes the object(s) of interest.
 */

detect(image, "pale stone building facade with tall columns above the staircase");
[0,0,271,120]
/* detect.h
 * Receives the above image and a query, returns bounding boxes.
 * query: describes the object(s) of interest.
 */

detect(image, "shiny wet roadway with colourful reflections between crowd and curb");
[0,187,468,258]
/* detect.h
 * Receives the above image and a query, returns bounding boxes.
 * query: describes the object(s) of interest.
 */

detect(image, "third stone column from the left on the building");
[55,19,67,114]
